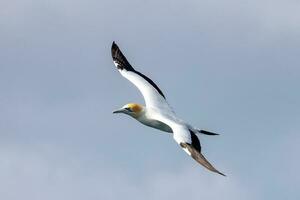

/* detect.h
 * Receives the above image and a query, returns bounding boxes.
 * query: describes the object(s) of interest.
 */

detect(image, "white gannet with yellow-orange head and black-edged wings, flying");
[111,42,225,176]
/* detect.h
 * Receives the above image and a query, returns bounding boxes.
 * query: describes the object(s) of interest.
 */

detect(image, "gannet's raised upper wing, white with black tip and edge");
[111,42,173,113]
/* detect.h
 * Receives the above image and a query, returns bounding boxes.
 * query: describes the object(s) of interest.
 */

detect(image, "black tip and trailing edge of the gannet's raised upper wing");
[111,42,166,99]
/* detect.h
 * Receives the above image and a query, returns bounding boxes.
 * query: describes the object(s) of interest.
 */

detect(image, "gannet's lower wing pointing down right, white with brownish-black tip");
[156,116,225,176]
